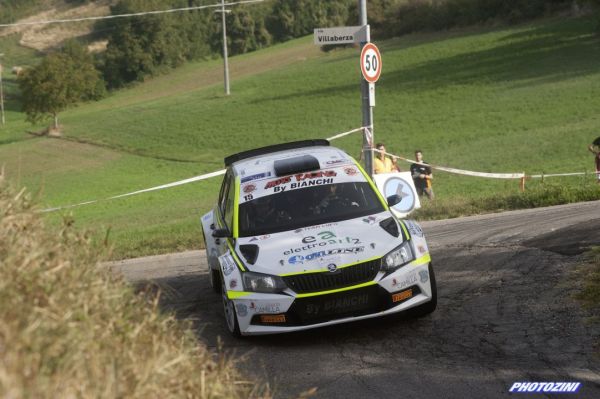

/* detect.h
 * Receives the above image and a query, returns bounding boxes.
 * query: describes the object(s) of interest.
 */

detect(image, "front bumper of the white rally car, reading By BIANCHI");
[232,264,432,335]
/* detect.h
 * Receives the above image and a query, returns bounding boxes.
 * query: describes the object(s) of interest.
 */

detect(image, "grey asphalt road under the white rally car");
[113,201,600,399]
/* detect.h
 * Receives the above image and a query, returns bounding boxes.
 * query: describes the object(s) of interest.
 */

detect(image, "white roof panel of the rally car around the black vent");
[231,146,355,177]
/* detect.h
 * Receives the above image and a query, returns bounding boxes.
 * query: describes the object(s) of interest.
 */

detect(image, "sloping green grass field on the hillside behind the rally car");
[0,14,600,257]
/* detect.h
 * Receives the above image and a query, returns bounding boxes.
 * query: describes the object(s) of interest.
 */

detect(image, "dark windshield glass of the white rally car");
[239,182,384,237]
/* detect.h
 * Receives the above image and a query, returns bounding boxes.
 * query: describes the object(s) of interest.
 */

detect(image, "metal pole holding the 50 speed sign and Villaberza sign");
[358,0,374,177]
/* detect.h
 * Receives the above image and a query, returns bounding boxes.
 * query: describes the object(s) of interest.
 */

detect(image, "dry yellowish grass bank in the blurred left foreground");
[0,181,268,398]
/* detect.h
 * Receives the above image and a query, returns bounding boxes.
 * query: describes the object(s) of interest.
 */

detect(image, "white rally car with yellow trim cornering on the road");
[202,140,437,335]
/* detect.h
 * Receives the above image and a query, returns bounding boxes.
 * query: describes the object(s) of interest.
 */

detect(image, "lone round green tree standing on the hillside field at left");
[18,42,106,129]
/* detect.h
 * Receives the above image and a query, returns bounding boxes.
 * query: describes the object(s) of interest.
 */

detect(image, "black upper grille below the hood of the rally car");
[283,259,381,294]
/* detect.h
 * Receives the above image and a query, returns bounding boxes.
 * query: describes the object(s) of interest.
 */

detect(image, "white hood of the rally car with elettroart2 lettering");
[236,211,403,275]
